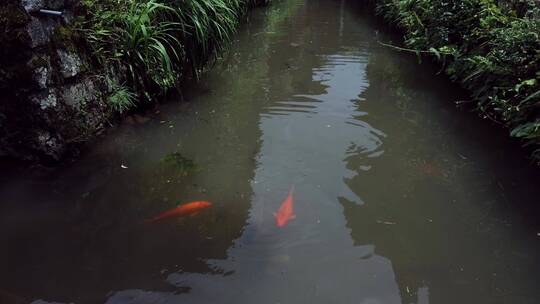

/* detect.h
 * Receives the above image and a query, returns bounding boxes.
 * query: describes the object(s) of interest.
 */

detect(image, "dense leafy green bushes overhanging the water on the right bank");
[373,0,540,161]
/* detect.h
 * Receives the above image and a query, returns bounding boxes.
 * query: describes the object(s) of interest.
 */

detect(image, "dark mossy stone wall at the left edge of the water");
[0,0,111,161]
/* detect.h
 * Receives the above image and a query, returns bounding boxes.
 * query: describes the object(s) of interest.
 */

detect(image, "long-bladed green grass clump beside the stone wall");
[76,0,267,113]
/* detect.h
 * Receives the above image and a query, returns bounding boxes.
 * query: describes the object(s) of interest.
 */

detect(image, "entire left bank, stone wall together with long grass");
[0,0,269,163]
